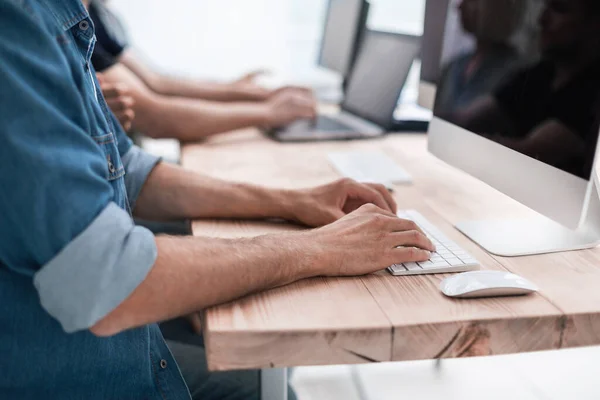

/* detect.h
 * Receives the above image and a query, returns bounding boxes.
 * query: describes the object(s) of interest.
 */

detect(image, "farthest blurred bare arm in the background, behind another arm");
[119,49,271,102]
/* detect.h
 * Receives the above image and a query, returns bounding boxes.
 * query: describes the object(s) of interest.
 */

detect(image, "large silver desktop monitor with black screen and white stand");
[429,0,600,256]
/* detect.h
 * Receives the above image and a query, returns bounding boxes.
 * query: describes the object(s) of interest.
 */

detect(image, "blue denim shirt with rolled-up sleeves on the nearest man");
[0,0,190,400]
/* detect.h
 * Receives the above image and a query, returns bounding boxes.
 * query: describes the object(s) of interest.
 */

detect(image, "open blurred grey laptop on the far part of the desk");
[267,30,420,142]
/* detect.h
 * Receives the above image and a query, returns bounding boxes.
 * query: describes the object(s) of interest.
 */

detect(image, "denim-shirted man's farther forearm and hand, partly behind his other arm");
[134,163,396,226]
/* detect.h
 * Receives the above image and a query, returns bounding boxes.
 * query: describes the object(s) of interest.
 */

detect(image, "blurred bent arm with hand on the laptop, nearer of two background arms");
[103,64,316,141]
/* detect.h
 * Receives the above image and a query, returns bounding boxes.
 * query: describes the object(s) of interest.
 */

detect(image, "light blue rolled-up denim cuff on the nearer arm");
[34,203,156,332]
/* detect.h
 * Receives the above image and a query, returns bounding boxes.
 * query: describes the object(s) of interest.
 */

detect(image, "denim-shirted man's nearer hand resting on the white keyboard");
[306,204,435,276]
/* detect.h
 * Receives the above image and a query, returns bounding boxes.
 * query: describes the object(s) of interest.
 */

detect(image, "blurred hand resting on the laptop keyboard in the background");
[266,87,317,128]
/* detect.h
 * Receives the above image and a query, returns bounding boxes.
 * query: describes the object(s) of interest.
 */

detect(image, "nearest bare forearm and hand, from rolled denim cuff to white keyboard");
[91,205,434,336]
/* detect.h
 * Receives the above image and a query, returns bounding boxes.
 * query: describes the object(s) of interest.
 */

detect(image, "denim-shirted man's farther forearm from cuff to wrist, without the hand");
[134,163,293,220]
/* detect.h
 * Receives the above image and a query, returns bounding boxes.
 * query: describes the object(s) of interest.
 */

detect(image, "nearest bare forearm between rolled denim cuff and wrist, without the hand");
[91,233,318,336]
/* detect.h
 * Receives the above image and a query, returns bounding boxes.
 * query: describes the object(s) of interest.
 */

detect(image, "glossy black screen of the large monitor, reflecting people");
[434,0,600,180]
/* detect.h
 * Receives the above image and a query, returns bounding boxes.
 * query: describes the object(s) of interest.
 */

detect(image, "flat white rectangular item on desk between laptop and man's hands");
[328,151,412,187]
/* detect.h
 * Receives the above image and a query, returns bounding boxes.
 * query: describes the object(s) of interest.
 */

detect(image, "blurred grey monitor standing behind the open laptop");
[318,0,369,79]
